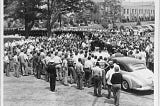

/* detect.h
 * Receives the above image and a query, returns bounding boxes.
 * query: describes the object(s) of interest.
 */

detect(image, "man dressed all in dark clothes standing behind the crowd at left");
[47,60,57,92]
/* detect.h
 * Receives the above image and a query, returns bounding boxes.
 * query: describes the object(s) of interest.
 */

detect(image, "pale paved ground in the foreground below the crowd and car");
[4,76,154,106]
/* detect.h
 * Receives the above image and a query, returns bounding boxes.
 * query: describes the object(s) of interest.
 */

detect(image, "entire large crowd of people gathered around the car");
[4,29,154,106]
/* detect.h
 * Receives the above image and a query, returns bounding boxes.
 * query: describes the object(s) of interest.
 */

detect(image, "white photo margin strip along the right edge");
[154,0,160,106]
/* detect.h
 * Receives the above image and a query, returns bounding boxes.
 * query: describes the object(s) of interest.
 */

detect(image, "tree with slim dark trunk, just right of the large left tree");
[46,0,81,36]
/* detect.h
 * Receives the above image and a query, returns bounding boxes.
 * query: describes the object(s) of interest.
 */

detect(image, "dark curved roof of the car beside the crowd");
[113,57,144,64]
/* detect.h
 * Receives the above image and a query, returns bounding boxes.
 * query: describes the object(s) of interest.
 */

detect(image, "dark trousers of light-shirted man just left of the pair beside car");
[93,76,102,96]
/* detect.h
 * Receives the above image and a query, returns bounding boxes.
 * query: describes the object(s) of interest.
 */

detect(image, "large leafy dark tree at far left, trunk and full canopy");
[4,0,43,37]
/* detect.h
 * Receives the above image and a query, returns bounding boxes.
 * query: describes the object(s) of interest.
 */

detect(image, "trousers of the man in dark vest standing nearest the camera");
[112,84,121,106]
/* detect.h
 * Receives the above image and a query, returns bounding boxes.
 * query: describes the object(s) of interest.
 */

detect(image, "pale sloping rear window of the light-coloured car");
[129,63,146,71]
